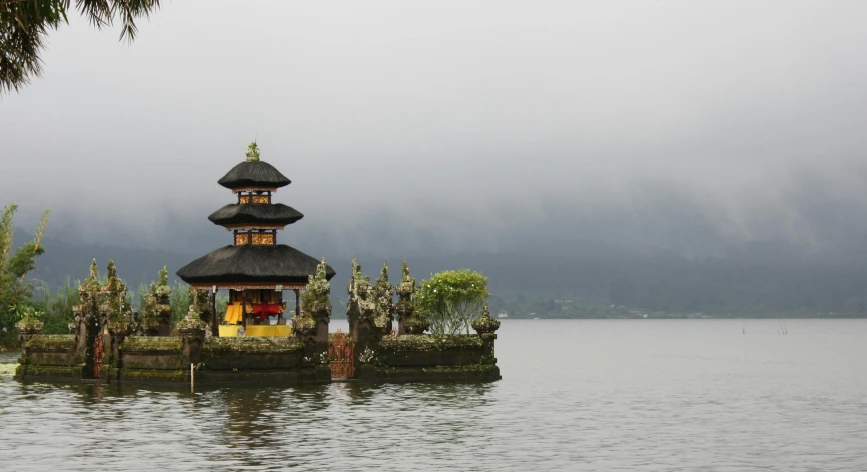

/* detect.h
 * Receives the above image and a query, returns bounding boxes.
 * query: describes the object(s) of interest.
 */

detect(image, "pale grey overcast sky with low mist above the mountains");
[0,0,867,258]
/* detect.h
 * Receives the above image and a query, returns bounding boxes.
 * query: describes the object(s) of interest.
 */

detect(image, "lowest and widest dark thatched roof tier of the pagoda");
[177,244,334,285]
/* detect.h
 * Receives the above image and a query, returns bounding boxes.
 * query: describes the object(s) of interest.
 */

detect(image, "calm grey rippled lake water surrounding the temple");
[0,320,867,472]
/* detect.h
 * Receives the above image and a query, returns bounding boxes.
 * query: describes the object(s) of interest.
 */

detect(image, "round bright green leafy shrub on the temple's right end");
[415,269,489,335]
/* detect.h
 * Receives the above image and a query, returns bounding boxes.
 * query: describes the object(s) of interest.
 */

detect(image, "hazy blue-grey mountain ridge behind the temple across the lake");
[15,218,867,316]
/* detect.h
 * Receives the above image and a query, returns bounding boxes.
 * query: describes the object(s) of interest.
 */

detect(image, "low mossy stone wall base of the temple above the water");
[16,332,501,387]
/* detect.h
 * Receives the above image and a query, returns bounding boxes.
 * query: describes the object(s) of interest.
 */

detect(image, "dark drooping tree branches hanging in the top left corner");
[0,0,160,93]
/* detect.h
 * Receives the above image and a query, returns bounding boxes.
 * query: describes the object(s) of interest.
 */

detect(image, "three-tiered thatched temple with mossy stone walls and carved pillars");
[16,143,501,386]
